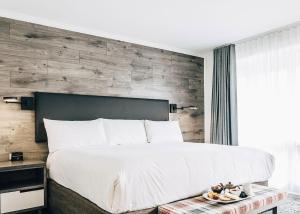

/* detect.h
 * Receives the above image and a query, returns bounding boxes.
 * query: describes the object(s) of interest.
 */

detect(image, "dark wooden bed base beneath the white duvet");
[47,179,268,214]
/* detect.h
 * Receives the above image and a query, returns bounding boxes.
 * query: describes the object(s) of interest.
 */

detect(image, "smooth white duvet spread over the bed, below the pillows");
[47,143,274,213]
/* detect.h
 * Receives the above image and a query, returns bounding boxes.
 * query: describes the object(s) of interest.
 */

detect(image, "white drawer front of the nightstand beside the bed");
[0,189,44,213]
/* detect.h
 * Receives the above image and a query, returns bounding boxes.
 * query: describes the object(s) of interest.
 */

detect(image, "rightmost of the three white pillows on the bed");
[145,120,183,144]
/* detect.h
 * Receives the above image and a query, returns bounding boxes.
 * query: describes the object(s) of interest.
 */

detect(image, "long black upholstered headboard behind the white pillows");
[34,92,169,143]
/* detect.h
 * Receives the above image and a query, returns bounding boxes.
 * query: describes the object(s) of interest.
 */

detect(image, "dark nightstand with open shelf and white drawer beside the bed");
[0,161,47,213]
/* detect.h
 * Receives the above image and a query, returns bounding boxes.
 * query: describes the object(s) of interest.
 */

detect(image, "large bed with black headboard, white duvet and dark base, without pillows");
[35,93,274,214]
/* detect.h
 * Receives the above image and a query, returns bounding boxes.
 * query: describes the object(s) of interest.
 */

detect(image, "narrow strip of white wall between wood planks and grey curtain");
[199,50,214,143]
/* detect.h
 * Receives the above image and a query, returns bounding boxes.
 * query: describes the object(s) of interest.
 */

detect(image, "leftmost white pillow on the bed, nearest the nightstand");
[44,119,107,153]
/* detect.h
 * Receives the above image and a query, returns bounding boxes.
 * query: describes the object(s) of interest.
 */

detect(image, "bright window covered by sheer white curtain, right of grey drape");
[236,26,300,193]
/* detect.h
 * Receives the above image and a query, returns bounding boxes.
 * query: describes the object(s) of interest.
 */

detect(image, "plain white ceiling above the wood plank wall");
[0,0,300,55]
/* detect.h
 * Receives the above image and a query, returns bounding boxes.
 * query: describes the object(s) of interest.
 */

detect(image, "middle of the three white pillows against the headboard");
[103,119,147,145]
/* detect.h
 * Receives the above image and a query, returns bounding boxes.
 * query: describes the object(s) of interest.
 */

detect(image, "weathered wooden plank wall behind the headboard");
[0,18,204,160]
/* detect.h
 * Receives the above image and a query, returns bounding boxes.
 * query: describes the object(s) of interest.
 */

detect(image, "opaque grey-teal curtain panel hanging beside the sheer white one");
[210,45,238,145]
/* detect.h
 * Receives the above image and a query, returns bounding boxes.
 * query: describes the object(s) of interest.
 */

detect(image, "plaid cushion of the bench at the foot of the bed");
[158,184,287,214]
